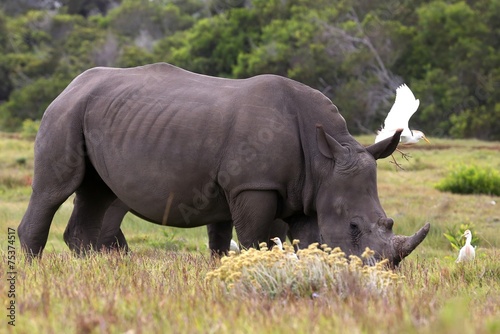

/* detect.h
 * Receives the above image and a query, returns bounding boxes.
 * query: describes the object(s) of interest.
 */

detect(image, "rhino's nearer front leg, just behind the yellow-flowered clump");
[230,190,278,248]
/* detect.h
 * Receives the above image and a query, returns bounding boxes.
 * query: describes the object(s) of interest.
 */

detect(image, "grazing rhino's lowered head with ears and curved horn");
[316,125,430,265]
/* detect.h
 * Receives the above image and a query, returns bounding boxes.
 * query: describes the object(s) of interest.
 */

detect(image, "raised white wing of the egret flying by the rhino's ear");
[384,84,420,133]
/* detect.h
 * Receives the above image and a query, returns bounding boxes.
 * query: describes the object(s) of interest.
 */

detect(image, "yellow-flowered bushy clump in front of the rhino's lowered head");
[206,244,402,299]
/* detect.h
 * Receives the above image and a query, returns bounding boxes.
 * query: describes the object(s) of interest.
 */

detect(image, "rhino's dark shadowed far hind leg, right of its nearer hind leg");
[64,164,115,254]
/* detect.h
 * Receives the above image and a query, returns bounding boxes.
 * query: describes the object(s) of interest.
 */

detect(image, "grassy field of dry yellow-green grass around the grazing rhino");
[0,134,500,333]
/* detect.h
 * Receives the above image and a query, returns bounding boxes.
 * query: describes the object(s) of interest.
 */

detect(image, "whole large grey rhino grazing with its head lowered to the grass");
[18,64,429,264]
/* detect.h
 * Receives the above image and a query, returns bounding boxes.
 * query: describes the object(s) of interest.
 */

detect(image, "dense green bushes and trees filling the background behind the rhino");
[0,0,500,140]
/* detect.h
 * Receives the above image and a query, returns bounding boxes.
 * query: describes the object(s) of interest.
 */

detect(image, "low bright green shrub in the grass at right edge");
[436,165,500,196]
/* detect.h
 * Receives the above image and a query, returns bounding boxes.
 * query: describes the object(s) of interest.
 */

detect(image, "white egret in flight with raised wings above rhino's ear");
[375,84,429,144]
